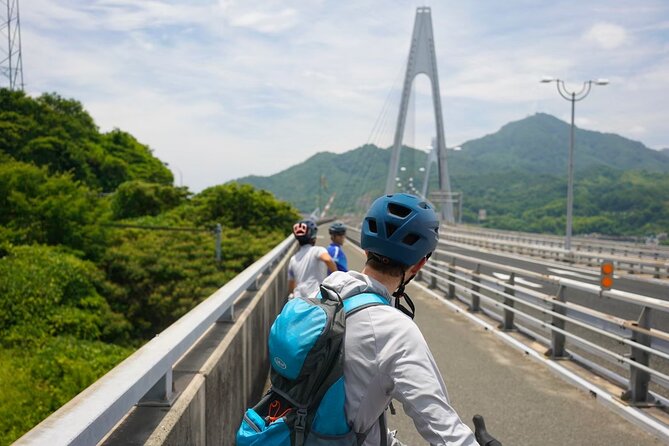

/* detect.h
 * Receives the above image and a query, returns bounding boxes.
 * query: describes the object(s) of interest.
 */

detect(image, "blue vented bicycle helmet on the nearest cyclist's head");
[360,194,439,266]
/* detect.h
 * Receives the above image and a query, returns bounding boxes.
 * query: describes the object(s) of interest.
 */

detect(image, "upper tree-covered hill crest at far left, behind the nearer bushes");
[0,89,173,192]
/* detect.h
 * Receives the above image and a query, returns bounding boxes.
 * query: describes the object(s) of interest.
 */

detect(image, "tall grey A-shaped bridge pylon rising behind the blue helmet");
[386,7,454,223]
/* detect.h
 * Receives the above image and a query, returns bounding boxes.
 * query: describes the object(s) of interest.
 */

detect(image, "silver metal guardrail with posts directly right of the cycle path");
[422,251,669,406]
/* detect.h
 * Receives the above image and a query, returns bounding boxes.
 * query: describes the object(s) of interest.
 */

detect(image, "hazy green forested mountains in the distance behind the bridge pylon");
[238,113,669,235]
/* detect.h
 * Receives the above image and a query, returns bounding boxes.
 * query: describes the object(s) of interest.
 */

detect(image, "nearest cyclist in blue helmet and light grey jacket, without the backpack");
[323,194,478,446]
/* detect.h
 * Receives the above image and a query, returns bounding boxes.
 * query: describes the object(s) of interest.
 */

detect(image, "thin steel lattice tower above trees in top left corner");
[0,0,23,90]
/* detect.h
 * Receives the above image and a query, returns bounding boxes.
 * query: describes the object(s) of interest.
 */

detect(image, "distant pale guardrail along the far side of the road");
[440,231,669,279]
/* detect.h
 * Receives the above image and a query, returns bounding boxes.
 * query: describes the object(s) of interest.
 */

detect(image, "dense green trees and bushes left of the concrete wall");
[0,89,299,444]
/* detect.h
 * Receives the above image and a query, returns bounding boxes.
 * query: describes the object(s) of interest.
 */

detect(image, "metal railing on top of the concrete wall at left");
[15,235,295,446]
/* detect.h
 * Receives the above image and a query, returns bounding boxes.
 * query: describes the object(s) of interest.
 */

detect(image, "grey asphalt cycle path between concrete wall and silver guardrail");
[334,238,662,446]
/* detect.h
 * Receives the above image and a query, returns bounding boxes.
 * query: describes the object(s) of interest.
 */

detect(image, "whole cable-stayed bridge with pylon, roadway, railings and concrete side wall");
[10,8,669,445]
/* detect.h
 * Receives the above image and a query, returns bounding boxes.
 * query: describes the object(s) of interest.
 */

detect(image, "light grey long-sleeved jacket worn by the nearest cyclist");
[323,271,478,446]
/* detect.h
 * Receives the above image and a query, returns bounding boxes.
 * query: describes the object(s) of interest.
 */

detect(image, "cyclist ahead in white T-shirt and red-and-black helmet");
[288,220,337,297]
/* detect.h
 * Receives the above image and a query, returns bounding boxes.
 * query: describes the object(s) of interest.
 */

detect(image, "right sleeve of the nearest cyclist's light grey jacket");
[379,316,478,446]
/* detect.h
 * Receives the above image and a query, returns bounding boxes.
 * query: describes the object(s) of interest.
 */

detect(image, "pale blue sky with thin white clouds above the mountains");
[15,0,669,191]
